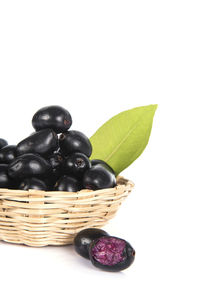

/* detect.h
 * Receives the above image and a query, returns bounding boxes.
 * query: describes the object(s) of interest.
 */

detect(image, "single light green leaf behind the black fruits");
[90,105,157,175]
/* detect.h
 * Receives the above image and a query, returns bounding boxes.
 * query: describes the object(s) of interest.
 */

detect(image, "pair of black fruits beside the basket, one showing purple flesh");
[74,228,135,272]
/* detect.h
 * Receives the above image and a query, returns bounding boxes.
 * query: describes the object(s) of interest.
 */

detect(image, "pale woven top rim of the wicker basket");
[0,176,135,199]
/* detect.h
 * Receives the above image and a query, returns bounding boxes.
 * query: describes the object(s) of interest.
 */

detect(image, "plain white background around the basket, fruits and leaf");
[0,0,200,299]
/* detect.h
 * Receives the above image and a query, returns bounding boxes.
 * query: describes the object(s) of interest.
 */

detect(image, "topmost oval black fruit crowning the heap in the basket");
[32,106,72,133]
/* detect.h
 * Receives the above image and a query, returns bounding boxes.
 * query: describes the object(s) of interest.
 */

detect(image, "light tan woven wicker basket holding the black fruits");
[0,177,134,247]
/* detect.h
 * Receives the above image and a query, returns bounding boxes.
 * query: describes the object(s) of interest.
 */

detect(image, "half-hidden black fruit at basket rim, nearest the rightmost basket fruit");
[54,175,81,192]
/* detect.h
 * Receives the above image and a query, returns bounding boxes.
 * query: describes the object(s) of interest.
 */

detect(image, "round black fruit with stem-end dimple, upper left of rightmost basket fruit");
[63,153,91,178]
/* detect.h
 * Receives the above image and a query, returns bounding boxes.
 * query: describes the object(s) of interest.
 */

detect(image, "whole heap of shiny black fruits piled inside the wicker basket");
[0,106,116,192]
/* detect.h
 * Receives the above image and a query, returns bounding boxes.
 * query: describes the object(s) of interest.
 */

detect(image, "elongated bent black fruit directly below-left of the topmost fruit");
[17,129,58,156]
